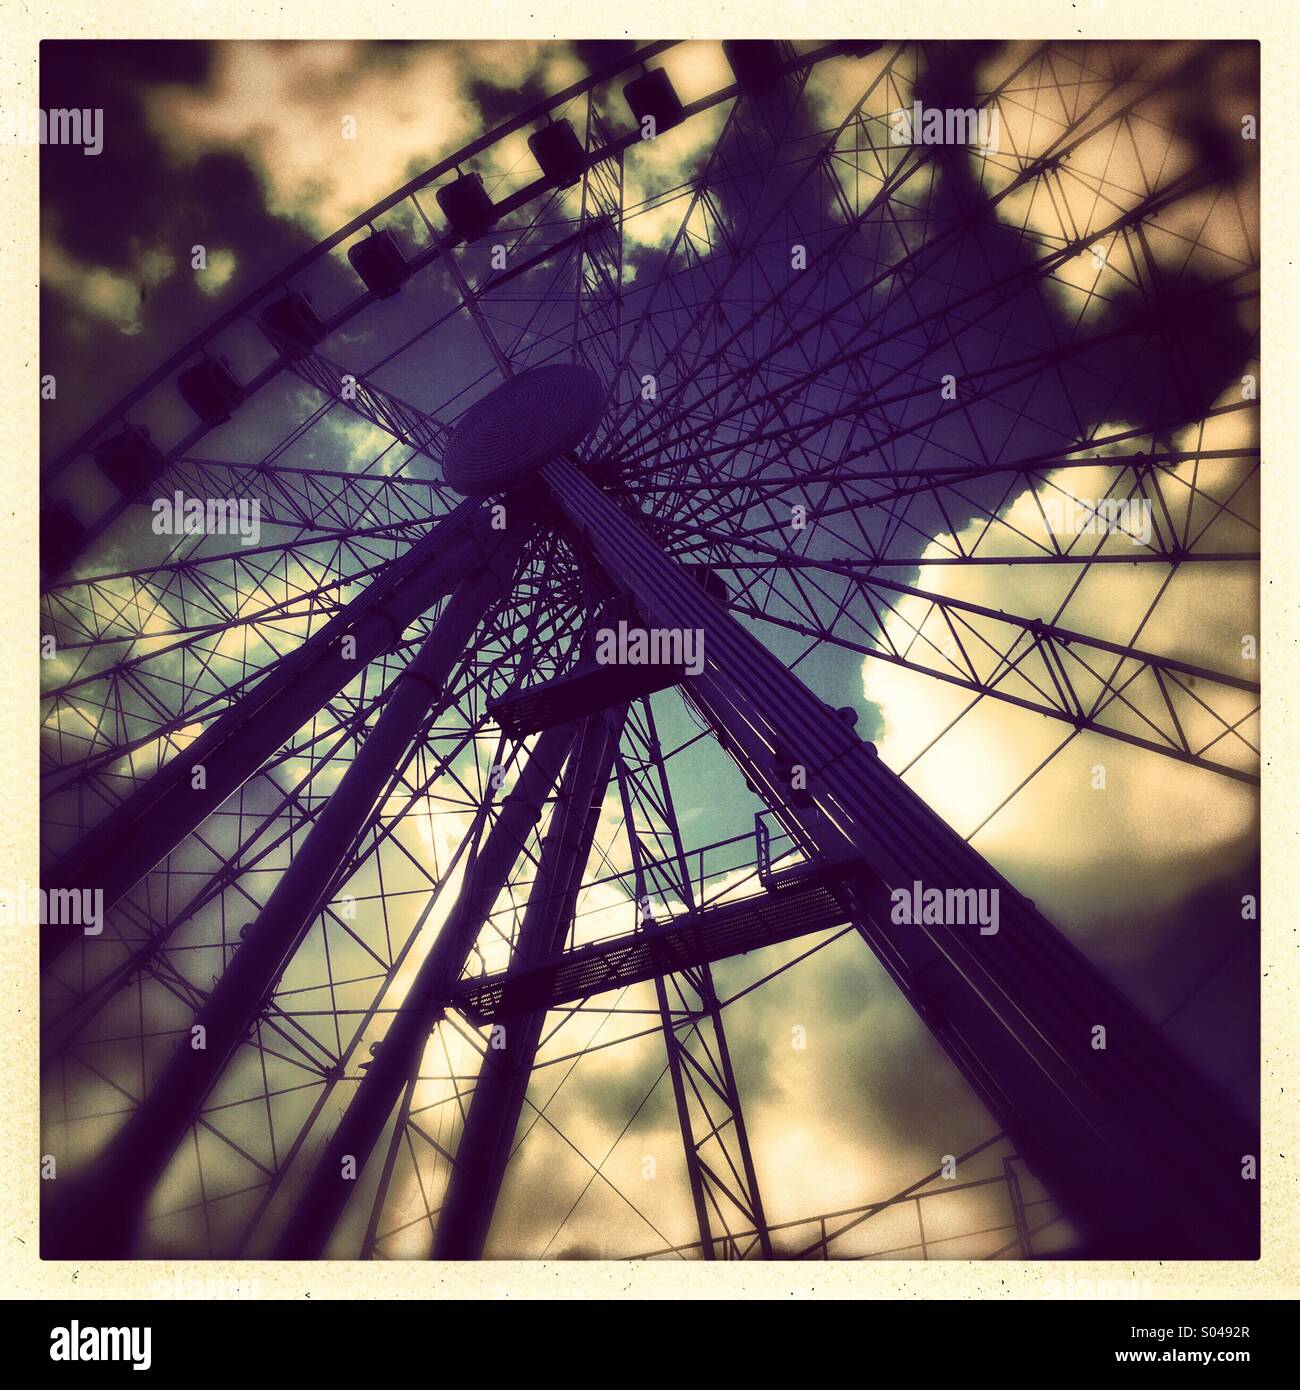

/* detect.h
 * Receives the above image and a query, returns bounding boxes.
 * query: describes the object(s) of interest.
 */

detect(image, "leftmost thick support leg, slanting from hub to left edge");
[40,503,496,965]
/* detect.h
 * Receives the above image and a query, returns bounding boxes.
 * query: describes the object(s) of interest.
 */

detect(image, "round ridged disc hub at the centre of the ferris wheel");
[444,361,608,498]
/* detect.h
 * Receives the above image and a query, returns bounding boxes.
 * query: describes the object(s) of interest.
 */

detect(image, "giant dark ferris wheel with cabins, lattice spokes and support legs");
[42,40,1260,1258]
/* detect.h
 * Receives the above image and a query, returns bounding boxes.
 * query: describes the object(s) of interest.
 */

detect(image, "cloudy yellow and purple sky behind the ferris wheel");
[42,42,1258,1257]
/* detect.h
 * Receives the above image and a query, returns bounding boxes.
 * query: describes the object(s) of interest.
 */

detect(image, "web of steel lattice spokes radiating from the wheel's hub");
[42,43,1258,1258]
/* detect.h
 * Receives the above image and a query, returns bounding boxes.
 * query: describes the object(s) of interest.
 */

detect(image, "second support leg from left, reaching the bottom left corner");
[42,522,523,1258]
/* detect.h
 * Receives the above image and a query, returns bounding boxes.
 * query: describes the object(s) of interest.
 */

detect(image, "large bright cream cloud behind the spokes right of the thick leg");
[862,439,1257,952]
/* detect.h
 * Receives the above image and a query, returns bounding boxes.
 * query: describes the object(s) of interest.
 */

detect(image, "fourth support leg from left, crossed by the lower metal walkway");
[432,712,621,1259]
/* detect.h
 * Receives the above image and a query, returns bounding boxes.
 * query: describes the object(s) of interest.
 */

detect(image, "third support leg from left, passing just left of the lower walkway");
[275,724,574,1259]
